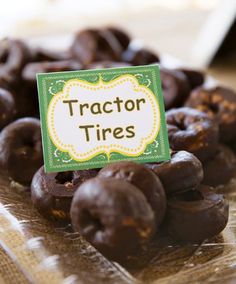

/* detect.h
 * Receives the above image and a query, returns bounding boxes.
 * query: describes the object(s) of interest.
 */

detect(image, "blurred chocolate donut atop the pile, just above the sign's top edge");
[71,29,122,66]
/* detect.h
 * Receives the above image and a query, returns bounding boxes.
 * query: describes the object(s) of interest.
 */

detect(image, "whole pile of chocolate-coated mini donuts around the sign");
[0,27,236,261]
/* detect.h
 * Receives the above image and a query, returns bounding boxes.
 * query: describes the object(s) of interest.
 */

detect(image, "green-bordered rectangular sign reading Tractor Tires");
[37,65,169,172]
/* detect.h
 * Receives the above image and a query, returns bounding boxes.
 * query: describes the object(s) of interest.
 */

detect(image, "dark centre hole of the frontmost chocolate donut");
[80,209,105,234]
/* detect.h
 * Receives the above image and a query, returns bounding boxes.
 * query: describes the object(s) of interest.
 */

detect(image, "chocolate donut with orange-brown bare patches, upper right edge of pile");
[185,86,236,142]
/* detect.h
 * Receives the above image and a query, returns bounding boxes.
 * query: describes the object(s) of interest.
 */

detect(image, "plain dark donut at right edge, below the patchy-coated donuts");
[203,145,236,186]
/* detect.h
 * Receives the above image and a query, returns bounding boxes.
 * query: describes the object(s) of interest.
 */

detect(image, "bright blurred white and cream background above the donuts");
[0,0,236,87]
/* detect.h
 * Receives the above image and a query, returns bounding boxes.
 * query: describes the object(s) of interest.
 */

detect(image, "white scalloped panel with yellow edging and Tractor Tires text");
[47,75,160,161]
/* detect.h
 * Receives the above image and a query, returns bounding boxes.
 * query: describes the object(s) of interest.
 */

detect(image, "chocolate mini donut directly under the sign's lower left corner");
[31,166,98,222]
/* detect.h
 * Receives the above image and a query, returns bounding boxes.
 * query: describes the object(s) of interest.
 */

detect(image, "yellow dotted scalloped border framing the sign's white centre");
[47,74,161,162]
